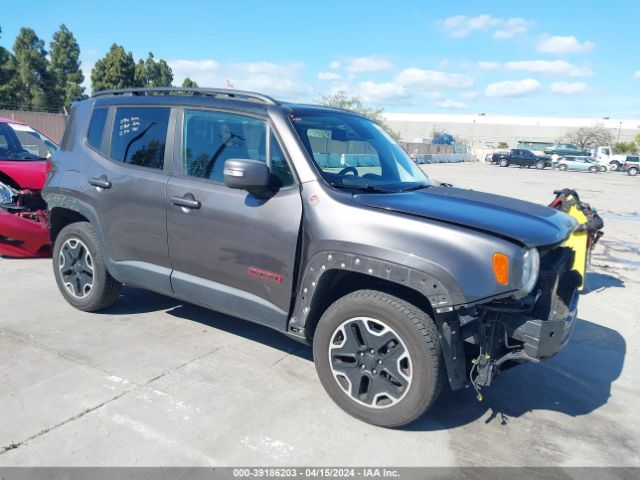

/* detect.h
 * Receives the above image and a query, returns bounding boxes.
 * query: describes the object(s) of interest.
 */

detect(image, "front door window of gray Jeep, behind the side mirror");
[182,110,293,187]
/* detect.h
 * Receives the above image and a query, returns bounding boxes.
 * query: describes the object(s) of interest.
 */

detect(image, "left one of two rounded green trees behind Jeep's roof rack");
[91,43,138,92]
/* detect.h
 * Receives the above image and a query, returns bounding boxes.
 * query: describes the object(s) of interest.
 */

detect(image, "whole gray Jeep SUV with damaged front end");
[44,89,581,427]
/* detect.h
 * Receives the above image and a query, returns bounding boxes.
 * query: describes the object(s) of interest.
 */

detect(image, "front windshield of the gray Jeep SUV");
[290,111,431,192]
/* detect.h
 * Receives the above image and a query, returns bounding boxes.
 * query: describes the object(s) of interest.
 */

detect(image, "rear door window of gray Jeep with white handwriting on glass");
[111,107,169,170]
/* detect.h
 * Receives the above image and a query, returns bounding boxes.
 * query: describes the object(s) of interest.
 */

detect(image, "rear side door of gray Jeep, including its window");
[86,105,175,293]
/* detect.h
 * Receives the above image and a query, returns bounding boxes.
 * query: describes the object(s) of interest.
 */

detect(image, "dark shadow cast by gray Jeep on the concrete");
[104,286,626,431]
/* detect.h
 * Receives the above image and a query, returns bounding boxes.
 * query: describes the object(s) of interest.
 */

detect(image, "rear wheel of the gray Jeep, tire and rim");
[53,222,122,312]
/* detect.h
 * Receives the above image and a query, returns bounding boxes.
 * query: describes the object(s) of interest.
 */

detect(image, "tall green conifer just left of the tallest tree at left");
[13,28,53,110]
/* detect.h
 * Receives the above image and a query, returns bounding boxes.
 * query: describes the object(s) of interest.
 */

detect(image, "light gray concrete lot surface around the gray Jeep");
[0,164,640,466]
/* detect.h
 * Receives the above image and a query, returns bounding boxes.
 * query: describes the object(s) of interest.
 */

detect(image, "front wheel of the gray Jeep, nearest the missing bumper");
[313,290,445,428]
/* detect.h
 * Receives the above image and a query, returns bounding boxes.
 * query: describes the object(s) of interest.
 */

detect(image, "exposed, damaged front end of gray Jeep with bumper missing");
[461,247,582,398]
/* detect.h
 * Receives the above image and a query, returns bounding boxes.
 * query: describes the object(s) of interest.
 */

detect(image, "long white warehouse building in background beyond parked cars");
[384,113,640,150]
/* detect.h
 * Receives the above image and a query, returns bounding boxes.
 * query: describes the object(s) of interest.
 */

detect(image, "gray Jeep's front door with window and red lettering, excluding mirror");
[167,110,302,329]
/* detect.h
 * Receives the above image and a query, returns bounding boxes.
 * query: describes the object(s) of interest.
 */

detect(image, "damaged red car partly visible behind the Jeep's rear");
[0,118,58,257]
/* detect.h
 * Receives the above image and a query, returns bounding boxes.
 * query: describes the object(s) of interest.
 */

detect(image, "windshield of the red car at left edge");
[0,123,58,160]
